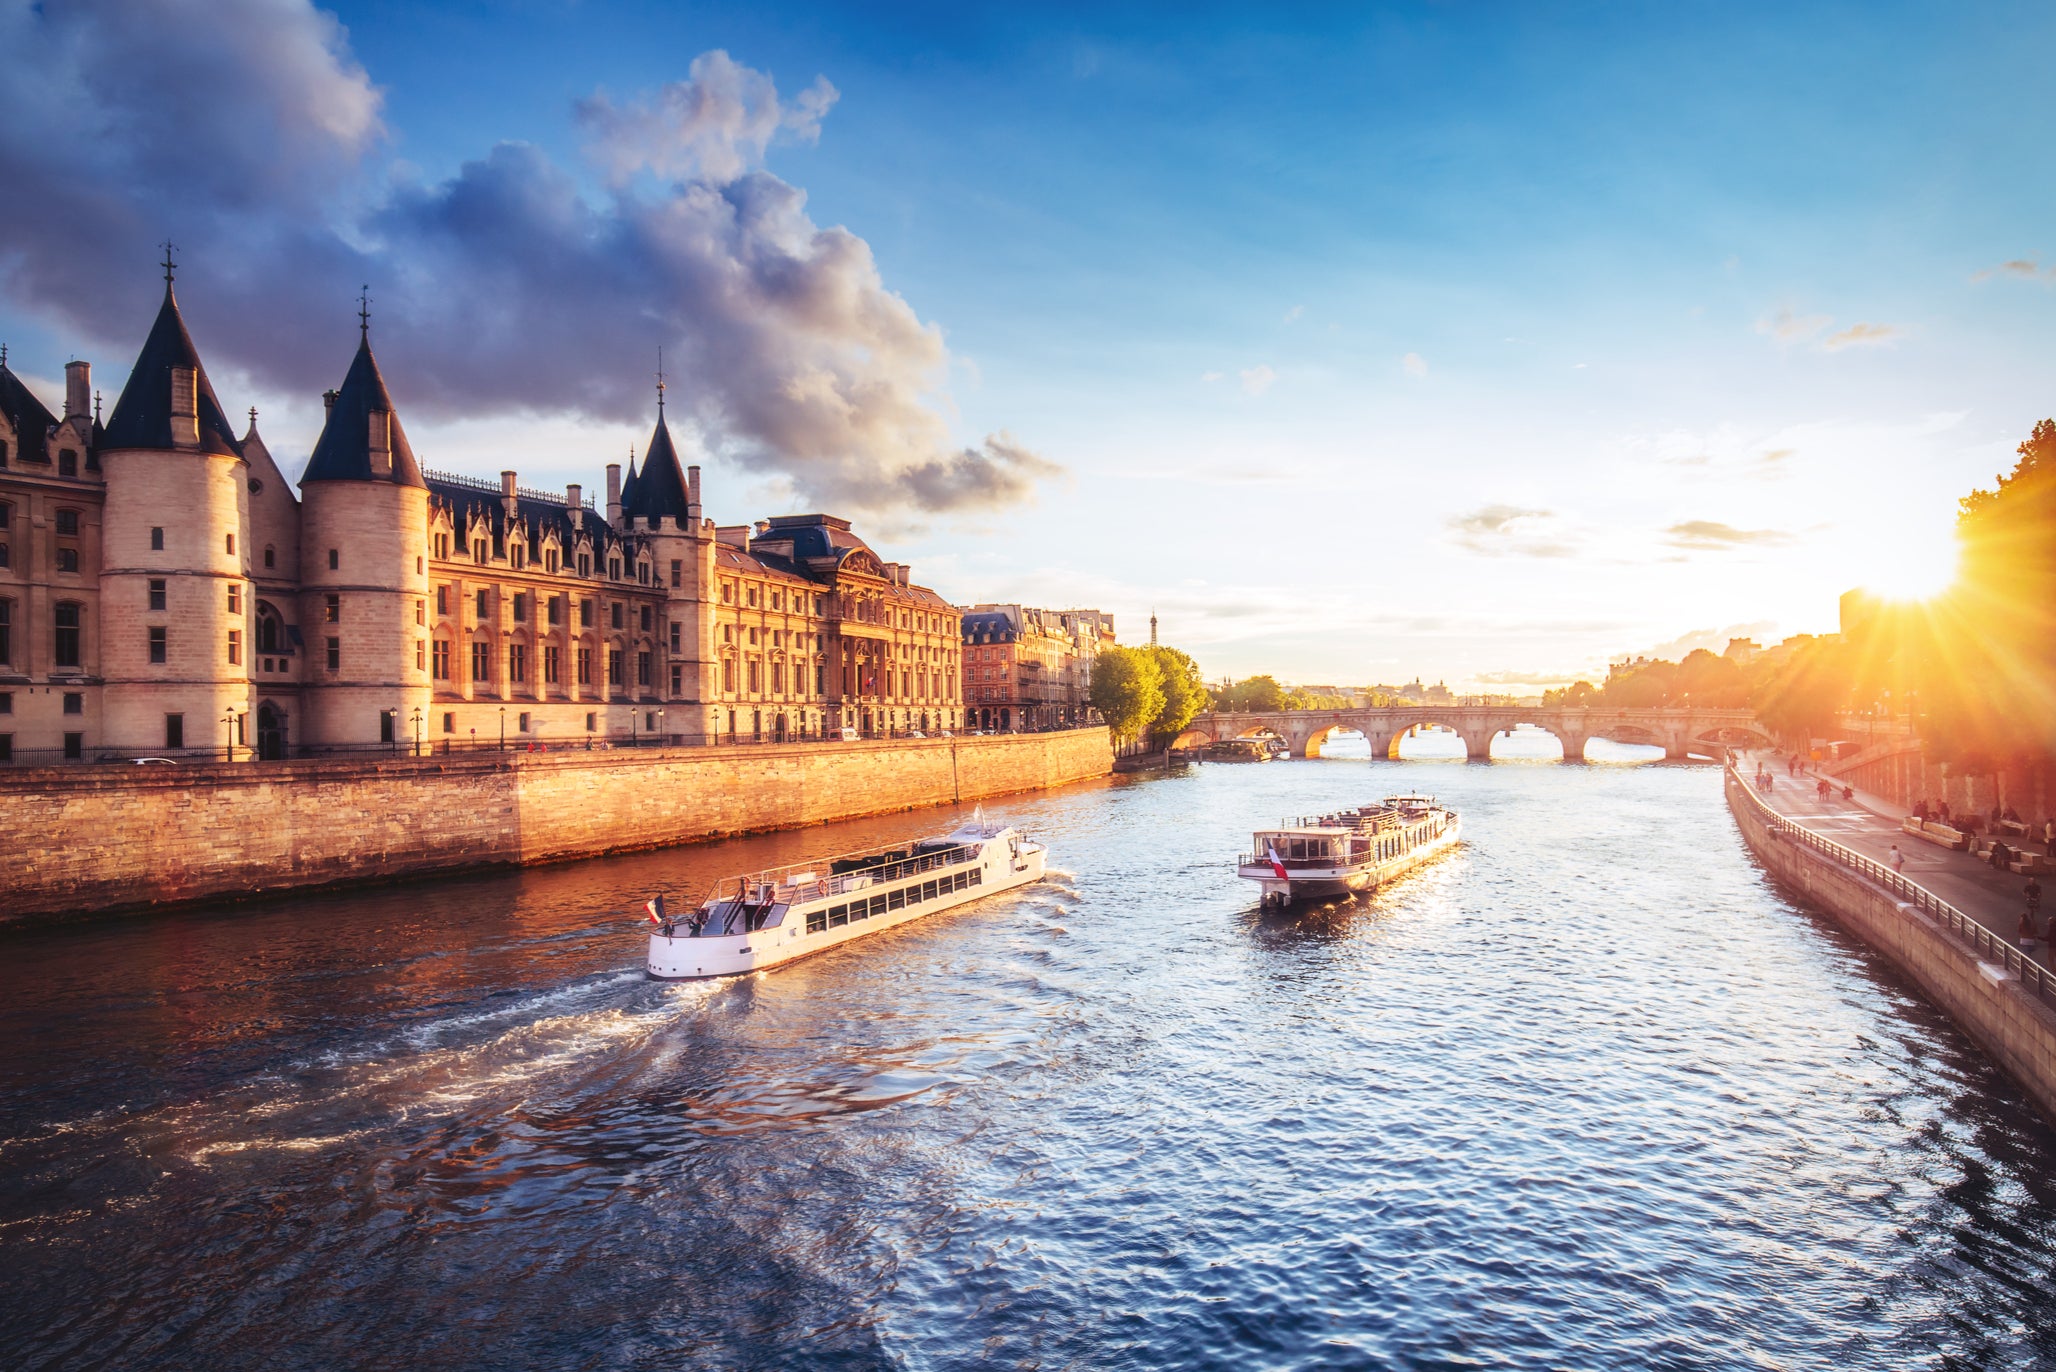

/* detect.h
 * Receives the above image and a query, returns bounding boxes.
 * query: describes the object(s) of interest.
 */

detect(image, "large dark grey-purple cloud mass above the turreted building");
[0,0,1057,514]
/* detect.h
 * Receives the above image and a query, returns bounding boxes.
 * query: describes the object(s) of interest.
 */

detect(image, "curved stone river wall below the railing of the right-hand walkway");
[1727,771,2056,1121]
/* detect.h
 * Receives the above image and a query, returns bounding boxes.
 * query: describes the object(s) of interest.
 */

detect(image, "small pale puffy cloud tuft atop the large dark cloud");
[576,49,839,185]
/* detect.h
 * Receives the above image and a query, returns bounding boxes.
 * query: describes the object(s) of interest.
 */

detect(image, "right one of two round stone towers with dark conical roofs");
[298,318,432,749]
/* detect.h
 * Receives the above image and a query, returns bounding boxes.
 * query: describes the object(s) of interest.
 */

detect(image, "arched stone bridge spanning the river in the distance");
[1172,706,1772,761]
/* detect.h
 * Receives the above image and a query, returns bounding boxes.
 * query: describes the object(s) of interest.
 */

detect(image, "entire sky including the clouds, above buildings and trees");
[0,0,2056,691]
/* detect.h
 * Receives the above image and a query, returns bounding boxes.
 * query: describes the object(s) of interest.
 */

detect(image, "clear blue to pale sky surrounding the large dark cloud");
[0,0,2056,689]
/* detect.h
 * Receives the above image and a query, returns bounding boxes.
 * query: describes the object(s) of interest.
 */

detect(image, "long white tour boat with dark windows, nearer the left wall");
[648,813,1047,981]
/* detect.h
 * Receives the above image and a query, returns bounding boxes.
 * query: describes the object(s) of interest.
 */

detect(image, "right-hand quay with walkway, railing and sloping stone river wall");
[1725,753,2056,1121]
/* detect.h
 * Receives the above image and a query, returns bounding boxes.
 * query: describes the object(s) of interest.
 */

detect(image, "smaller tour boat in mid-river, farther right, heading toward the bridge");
[1236,796,1460,905]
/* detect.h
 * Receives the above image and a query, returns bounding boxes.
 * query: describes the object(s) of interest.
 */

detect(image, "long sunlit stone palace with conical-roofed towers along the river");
[0,280,962,761]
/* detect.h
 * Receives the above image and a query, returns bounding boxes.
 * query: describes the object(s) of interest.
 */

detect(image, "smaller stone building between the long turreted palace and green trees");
[962,605,1114,732]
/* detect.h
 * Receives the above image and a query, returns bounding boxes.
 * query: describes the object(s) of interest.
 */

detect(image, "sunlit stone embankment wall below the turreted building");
[0,728,1114,922]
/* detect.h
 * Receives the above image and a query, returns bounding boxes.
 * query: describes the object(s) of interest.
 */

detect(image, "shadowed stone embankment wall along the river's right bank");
[1727,769,2056,1123]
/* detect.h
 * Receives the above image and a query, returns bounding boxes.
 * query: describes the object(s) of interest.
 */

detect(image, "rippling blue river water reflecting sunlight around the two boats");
[0,745,2056,1372]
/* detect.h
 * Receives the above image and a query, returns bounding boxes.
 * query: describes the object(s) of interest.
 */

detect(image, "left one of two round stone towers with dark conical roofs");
[99,267,253,757]
